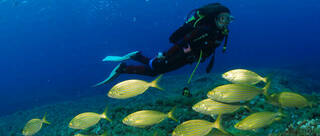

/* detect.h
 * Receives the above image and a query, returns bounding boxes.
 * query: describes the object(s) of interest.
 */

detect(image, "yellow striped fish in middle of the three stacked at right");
[207,82,270,103]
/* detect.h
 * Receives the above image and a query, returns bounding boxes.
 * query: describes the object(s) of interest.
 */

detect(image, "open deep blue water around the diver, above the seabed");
[0,0,320,116]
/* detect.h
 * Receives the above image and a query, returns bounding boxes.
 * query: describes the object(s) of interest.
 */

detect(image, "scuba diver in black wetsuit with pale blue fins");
[96,3,234,91]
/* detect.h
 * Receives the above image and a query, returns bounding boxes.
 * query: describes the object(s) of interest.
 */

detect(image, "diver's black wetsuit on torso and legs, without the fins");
[117,24,225,76]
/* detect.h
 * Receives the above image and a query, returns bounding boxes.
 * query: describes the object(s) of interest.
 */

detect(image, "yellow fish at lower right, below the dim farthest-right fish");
[234,111,285,131]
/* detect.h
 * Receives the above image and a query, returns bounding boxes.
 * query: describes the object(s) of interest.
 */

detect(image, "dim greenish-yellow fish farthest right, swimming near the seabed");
[267,92,312,108]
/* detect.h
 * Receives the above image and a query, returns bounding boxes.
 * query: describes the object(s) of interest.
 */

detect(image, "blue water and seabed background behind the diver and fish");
[0,0,320,136]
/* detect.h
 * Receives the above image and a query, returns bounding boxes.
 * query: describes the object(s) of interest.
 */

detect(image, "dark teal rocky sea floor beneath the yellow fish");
[0,69,320,136]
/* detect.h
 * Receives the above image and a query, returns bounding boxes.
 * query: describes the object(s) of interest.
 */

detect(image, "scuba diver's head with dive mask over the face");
[215,12,234,30]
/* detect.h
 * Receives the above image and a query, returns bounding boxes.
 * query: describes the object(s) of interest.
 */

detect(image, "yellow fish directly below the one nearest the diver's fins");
[122,108,178,128]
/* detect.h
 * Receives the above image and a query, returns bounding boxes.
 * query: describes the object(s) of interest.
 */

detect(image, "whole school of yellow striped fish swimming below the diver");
[22,69,312,136]
